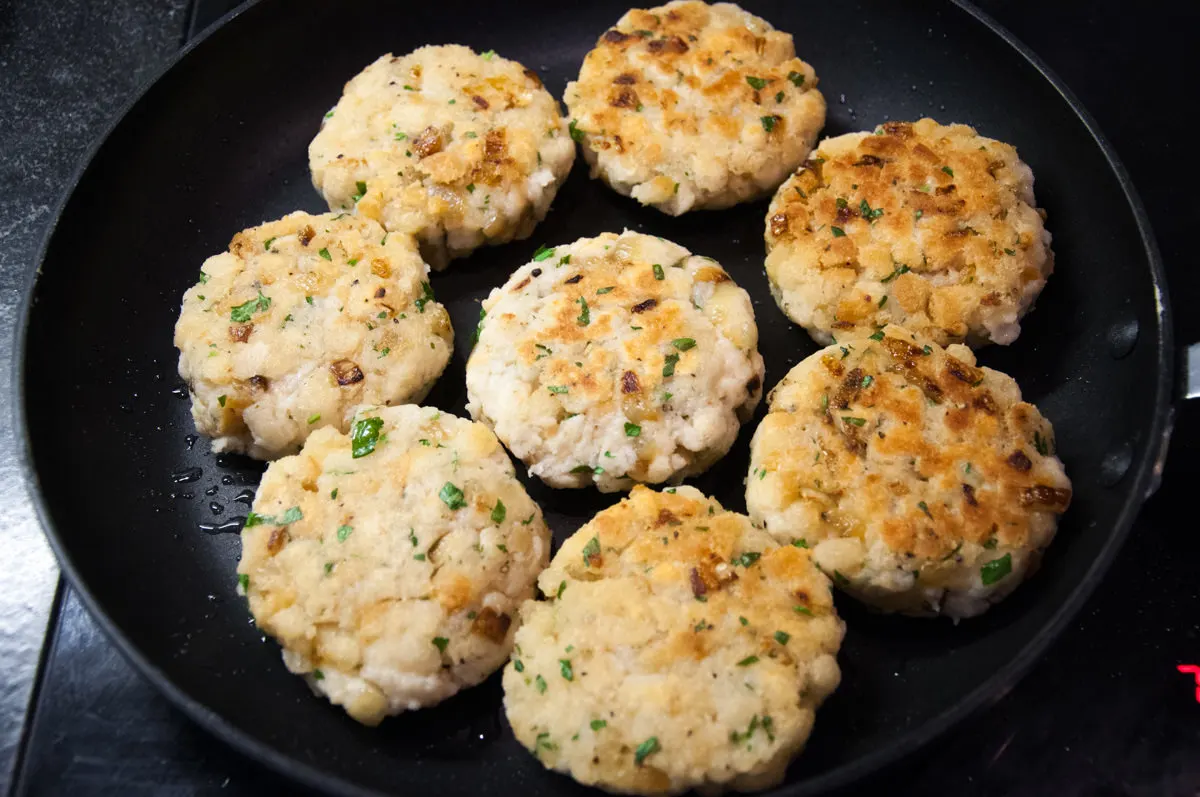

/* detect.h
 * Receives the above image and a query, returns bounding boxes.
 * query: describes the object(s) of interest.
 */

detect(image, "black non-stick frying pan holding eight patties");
[17,0,1174,797]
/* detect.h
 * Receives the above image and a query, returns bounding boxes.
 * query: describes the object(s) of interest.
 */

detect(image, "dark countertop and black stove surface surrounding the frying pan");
[0,0,1200,797]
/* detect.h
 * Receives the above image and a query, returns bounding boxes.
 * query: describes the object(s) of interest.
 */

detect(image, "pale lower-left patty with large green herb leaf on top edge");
[238,406,550,725]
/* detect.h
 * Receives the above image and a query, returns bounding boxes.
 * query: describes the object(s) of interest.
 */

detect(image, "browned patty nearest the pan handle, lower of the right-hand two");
[746,326,1072,619]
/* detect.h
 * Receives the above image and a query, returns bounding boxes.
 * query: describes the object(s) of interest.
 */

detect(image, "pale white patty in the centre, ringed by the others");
[467,230,763,492]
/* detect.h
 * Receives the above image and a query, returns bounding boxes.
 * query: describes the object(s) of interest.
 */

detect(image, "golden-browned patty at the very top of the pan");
[565,0,826,216]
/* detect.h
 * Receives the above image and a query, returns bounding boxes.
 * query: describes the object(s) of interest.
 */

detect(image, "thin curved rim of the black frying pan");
[11,0,1176,797]
